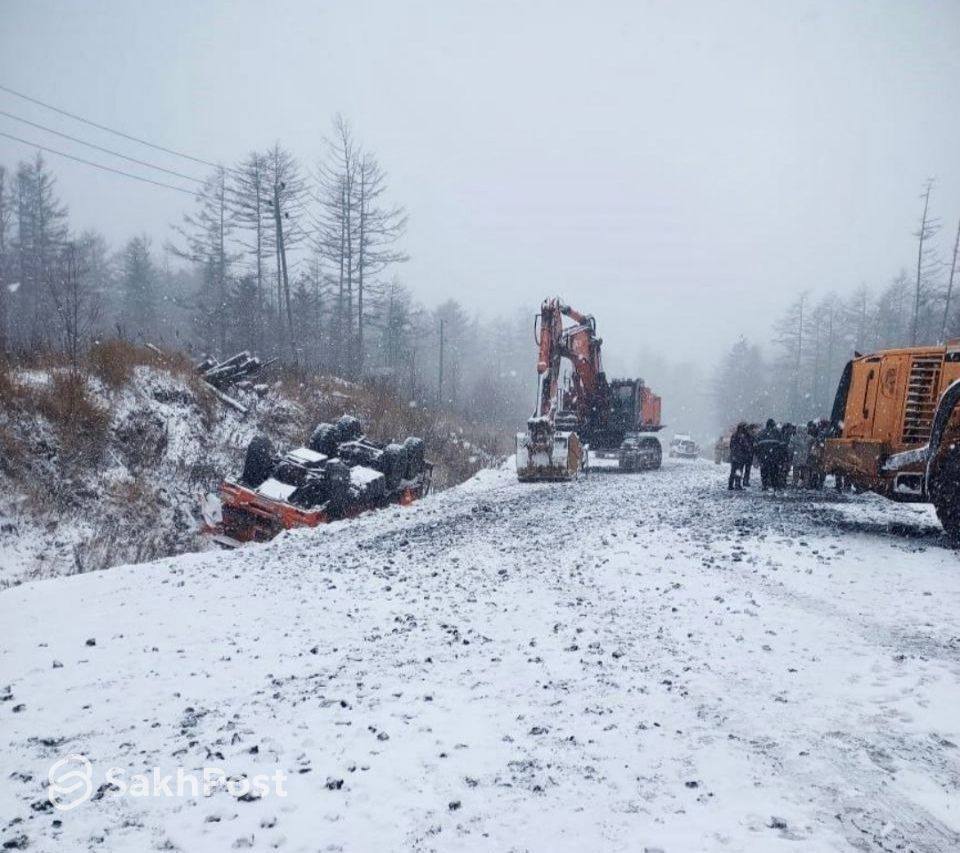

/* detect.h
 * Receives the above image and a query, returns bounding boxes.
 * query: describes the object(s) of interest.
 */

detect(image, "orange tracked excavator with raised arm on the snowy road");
[517,297,663,482]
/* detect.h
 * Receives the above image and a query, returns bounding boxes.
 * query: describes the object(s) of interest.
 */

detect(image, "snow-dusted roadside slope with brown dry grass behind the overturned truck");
[0,352,494,588]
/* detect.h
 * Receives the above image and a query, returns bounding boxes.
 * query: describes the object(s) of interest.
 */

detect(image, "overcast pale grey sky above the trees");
[0,0,960,366]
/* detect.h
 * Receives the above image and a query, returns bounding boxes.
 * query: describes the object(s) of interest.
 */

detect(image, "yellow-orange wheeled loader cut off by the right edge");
[823,340,960,538]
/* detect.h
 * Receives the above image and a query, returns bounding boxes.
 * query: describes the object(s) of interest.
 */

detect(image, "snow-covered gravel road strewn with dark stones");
[0,460,960,853]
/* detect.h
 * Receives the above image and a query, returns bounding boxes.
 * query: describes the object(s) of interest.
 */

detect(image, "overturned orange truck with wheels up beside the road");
[203,415,433,547]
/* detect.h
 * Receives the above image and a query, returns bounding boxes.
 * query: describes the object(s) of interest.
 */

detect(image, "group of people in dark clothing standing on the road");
[727,418,830,491]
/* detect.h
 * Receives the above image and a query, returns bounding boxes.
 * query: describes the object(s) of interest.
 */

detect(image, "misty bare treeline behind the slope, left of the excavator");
[0,117,537,430]
